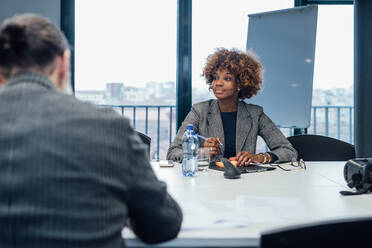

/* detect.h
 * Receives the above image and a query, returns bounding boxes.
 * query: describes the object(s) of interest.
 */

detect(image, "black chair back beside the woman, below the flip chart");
[287,134,355,161]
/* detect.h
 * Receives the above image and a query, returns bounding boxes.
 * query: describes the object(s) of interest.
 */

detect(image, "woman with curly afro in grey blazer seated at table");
[167,48,297,166]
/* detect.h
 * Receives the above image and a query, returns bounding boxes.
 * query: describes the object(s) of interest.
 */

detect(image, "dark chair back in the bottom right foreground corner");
[260,217,372,248]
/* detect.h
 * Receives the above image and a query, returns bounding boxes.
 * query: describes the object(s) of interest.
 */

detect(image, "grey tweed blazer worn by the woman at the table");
[167,100,297,162]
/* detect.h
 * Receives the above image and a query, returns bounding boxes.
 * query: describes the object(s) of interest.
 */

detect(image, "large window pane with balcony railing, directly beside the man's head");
[75,0,177,158]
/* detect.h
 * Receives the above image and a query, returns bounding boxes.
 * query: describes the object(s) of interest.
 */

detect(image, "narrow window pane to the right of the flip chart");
[309,5,354,143]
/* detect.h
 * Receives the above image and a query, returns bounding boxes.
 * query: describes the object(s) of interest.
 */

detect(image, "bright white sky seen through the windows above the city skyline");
[74,0,353,90]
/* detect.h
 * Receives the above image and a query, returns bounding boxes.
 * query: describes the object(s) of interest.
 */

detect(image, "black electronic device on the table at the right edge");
[340,158,372,195]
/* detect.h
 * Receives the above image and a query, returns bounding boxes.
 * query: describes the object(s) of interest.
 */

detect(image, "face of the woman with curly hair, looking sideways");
[212,69,239,101]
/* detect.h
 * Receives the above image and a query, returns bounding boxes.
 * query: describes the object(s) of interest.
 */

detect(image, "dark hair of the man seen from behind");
[0,14,68,71]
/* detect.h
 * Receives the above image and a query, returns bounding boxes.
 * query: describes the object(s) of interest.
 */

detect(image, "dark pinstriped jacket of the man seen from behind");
[0,73,182,248]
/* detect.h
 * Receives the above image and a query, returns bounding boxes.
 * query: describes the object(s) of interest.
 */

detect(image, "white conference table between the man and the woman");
[123,162,372,247]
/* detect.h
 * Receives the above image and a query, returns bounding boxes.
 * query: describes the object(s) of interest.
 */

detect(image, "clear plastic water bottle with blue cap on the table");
[182,124,199,177]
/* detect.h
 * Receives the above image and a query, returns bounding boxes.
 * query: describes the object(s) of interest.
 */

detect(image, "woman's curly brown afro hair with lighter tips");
[202,48,263,100]
